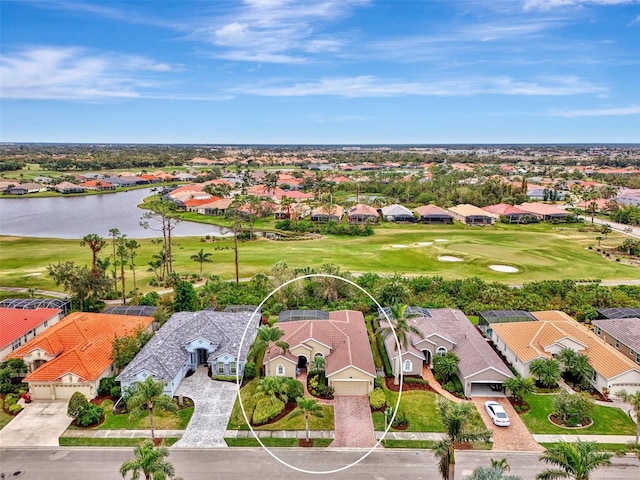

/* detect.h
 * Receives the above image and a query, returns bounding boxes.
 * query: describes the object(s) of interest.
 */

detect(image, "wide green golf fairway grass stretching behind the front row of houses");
[0,223,639,292]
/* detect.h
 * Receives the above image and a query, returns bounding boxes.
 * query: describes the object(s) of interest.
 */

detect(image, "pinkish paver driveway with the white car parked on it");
[471,397,544,452]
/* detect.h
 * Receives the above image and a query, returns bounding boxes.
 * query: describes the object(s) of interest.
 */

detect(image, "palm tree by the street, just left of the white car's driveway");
[433,397,491,480]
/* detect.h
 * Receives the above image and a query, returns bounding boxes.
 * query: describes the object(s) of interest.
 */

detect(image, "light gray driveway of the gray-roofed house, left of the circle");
[174,368,238,448]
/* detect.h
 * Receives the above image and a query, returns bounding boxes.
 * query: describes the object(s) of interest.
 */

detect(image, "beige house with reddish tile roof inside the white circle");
[263,310,376,395]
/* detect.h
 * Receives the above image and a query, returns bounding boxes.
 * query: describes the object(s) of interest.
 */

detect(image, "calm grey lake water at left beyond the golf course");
[0,188,227,238]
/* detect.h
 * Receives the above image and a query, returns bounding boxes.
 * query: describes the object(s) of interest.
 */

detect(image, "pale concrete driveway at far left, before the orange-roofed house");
[0,400,73,447]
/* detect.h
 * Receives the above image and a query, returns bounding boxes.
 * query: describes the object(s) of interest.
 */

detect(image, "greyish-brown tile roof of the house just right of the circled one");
[380,308,513,378]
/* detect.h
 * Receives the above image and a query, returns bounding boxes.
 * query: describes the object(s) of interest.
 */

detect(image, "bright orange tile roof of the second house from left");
[10,312,153,382]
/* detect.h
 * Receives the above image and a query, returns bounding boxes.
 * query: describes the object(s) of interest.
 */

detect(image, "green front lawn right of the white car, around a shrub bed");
[520,395,636,435]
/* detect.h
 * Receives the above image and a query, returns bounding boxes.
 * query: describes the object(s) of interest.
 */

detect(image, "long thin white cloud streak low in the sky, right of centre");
[232,75,604,98]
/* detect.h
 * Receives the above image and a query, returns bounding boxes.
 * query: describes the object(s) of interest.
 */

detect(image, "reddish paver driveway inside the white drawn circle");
[330,395,376,448]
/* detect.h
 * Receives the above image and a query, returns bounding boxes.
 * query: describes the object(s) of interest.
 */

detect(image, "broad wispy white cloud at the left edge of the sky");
[0,46,228,101]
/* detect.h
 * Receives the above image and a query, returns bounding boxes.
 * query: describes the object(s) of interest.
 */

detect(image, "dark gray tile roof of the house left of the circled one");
[118,310,260,380]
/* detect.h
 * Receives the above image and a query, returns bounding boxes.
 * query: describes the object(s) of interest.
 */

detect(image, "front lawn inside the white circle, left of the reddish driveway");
[227,378,333,430]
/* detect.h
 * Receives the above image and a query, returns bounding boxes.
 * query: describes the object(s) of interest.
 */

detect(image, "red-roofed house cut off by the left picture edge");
[0,308,62,362]
